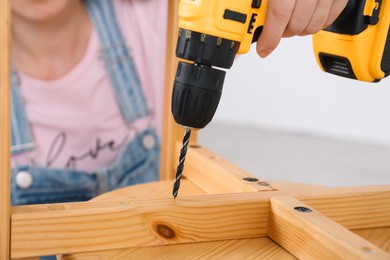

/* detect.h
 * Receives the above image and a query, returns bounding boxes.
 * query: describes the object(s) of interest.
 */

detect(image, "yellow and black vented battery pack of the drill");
[313,0,390,82]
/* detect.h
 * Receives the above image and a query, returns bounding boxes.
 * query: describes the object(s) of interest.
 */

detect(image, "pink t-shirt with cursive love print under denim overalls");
[12,0,168,171]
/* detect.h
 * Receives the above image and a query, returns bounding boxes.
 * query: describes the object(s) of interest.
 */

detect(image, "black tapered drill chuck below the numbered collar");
[171,62,225,129]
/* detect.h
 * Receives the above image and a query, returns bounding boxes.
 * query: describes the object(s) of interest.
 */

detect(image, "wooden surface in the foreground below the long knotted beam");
[59,237,296,260]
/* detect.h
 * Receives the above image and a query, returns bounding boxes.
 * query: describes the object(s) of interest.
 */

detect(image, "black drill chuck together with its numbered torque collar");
[171,29,235,129]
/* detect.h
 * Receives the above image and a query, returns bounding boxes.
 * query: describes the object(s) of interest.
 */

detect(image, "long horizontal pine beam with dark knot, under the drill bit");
[11,186,390,257]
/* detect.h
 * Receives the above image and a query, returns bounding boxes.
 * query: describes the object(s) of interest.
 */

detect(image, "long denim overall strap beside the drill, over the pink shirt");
[85,0,149,123]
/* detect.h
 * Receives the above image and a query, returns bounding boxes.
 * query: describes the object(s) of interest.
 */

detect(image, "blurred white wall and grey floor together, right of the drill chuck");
[199,36,390,186]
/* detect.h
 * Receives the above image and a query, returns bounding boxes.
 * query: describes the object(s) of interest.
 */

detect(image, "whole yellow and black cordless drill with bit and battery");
[172,0,390,198]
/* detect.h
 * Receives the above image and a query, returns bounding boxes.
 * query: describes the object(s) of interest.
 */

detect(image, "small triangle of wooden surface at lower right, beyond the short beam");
[352,227,390,253]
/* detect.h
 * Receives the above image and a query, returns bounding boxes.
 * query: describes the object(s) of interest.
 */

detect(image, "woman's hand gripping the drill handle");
[257,0,348,58]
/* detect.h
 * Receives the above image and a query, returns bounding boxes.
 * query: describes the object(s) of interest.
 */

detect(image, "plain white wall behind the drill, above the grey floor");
[213,36,390,145]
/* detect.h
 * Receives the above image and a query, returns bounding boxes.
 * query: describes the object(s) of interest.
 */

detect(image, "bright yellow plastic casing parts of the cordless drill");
[179,0,390,82]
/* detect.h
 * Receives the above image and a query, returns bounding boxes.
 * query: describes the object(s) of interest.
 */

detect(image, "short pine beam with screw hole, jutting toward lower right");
[268,197,390,259]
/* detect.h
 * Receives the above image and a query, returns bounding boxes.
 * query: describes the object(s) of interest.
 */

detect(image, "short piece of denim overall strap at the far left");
[11,68,35,154]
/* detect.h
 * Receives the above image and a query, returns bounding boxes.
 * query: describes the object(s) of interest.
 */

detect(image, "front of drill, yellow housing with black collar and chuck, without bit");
[172,0,267,129]
